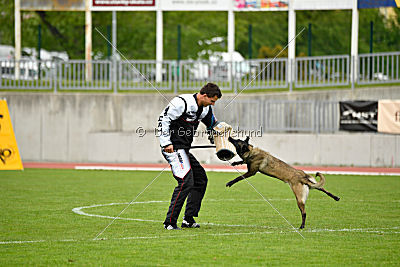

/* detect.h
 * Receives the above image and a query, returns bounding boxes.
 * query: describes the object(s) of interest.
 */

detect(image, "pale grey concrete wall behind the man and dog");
[0,87,400,167]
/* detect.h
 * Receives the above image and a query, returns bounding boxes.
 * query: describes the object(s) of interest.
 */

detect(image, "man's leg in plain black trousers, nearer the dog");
[185,153,208,223]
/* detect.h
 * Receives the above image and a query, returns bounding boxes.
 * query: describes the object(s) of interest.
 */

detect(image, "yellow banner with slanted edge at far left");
[0,100,24,170]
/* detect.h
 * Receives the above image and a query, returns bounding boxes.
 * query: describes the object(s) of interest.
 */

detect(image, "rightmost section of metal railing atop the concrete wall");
[357,52,400,84]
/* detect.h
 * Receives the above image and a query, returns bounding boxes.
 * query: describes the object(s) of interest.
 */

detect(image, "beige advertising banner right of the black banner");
[378,100,400,134]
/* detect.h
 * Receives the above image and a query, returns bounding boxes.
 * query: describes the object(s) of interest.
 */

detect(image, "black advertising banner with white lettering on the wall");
[339,101,378,132]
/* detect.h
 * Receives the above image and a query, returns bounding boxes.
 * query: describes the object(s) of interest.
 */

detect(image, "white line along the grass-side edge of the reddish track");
[75,165,400,176]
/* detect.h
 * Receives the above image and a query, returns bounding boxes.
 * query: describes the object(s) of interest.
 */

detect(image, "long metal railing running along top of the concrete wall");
[0,52,400,93]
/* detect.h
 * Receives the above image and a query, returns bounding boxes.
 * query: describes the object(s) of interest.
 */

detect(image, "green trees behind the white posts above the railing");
[0,4,400,60]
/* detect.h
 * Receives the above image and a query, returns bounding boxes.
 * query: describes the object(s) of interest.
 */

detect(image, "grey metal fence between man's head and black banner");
[215,99,339,133]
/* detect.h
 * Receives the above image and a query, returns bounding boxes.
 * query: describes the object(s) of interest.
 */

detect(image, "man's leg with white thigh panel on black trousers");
[163,149,193,226]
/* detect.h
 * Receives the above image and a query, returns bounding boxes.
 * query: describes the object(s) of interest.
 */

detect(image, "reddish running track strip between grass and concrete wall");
[23,162,400,176]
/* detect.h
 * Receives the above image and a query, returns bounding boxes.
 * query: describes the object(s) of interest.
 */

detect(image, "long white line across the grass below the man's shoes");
[0,227,400,245]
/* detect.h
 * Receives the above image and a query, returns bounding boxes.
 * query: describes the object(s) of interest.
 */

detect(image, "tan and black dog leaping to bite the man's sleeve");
[226,137,340,229]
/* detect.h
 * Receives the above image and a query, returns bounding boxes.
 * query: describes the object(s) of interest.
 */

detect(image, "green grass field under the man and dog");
[0,169,400,266]
